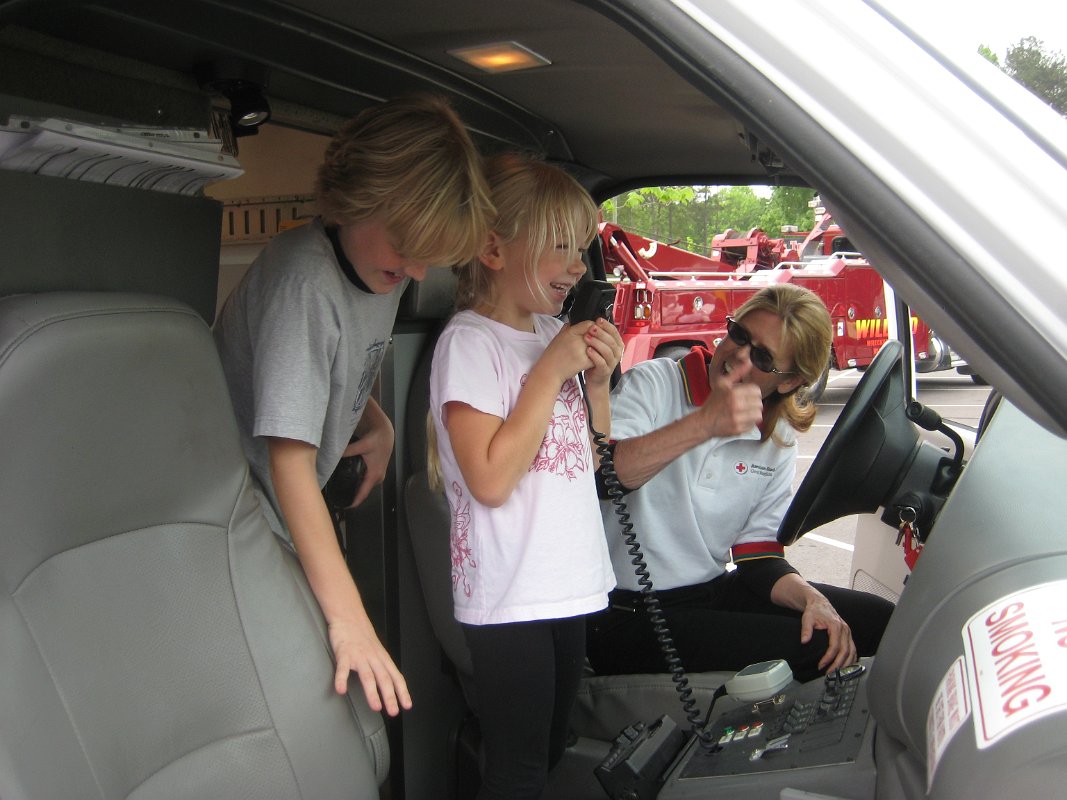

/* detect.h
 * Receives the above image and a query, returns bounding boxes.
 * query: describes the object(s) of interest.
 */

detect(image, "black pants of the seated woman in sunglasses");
[589,572,894,682]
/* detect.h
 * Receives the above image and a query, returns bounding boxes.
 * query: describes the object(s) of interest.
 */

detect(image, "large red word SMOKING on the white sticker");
[986,603,1052,717]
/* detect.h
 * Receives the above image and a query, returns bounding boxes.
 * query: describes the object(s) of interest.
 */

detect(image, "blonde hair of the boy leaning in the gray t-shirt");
[316,95,493,266]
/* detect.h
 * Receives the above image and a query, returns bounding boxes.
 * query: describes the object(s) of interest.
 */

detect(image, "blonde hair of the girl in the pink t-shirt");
[456,153,599,310]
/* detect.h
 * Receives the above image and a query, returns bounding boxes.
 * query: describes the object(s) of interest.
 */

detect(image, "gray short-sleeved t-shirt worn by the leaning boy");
[214,220,408,539]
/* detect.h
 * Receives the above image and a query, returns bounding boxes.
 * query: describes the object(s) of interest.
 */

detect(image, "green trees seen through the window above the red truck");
[601,186,814,254]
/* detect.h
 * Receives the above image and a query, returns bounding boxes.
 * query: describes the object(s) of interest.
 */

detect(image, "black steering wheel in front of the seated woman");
[778,339,919,545]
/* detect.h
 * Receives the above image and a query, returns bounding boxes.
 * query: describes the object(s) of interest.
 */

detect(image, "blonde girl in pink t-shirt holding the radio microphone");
[430,155,622,800]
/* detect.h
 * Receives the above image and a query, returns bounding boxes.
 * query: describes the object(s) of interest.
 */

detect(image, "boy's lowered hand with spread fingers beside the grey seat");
[329,620,411,717]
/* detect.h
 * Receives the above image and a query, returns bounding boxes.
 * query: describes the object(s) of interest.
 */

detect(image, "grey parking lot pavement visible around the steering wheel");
[785,369,990,587]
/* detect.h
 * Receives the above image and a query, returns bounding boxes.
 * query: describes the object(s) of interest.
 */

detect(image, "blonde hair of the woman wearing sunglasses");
[735,284,833,444]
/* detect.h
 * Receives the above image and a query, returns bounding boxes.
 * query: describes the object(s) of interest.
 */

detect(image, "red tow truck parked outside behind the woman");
[599,214,952,400]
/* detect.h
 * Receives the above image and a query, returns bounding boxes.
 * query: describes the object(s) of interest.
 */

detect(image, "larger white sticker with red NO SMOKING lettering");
[962,580,1067,748]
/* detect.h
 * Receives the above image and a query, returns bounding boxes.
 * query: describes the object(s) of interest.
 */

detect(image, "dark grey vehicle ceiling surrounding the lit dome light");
[0,0,785,193]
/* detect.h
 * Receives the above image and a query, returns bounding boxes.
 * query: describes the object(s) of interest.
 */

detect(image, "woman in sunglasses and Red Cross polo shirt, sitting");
[589,284,893,681]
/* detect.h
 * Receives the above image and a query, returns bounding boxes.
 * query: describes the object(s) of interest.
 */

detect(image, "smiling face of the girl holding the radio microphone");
[482,234,586,330]
